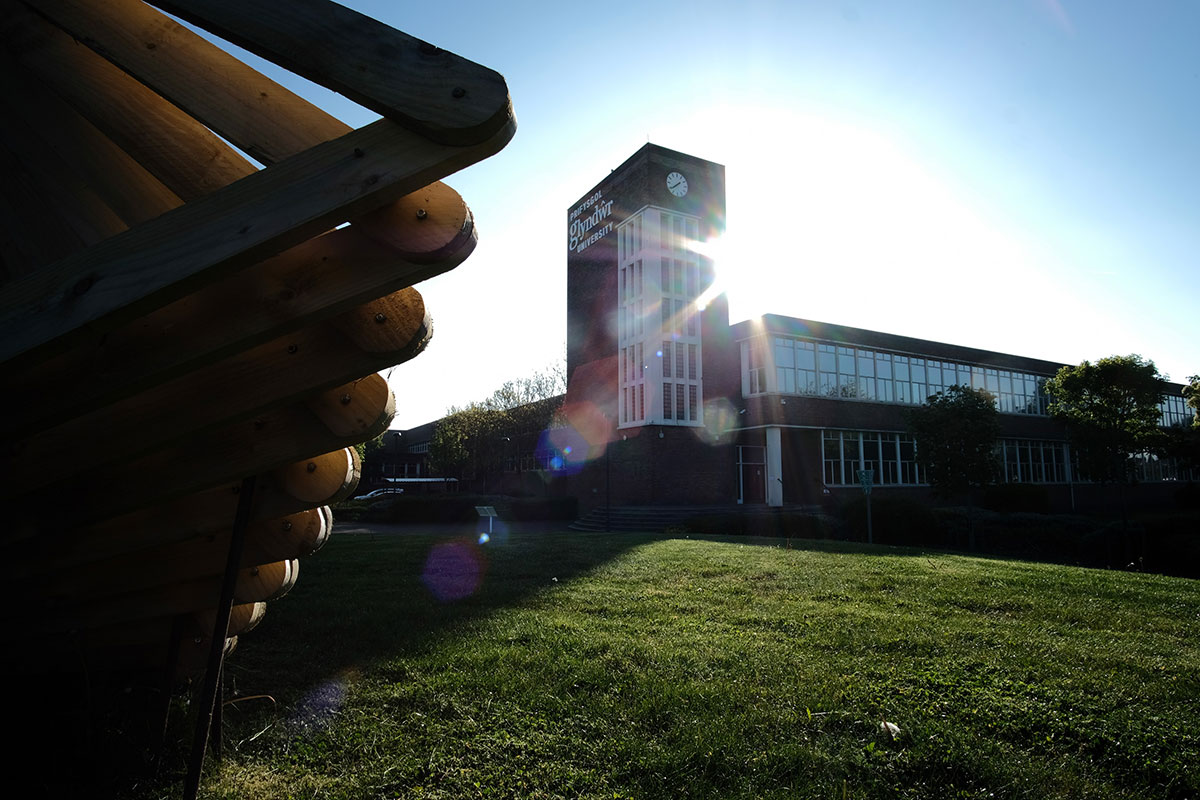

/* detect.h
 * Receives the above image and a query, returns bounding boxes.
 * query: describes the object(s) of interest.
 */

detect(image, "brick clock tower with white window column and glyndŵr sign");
[566,144,728,438]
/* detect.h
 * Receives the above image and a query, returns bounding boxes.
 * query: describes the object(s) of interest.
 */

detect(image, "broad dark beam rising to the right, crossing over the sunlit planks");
[0,113,511,369]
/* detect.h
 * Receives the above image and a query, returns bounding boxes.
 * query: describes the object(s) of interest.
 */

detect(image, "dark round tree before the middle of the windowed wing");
[907,386,1000,498]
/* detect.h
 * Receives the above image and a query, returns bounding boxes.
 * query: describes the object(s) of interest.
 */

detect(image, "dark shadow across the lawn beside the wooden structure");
[227,523,659,705]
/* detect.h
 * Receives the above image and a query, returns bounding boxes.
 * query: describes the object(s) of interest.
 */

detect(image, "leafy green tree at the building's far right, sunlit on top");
[1045,355,1166,486]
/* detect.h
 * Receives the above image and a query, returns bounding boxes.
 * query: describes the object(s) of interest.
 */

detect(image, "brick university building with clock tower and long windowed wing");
[564,144,1194,509]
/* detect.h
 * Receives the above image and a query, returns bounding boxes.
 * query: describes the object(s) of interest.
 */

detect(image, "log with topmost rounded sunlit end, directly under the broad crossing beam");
[0,182,475,438]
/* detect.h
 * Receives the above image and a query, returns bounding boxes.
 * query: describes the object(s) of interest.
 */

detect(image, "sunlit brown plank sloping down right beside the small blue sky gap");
[21,0,350,164]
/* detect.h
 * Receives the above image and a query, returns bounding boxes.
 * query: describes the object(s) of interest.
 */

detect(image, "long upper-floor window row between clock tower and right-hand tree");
[749,336,1046,414]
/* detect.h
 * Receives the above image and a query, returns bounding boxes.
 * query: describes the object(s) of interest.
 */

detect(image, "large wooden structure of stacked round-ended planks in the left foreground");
[0,0,515,690]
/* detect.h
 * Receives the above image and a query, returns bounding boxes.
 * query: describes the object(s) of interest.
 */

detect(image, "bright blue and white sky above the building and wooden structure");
[211,0,1200,428]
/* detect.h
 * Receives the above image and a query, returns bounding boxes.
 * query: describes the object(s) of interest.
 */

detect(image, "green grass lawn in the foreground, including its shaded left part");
[173,533,1200,799]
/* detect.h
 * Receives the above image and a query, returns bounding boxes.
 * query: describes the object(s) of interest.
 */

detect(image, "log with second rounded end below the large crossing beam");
[0,289,432,498]
